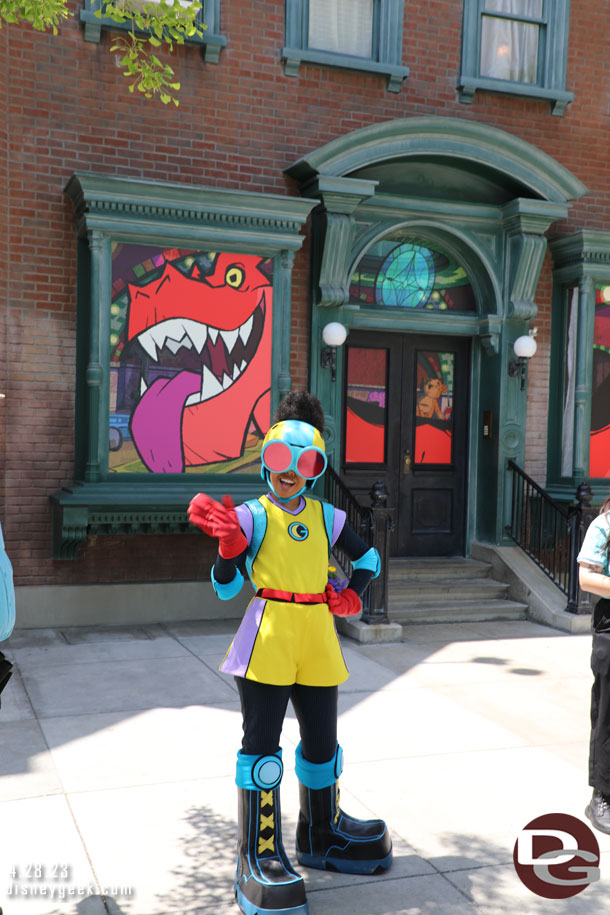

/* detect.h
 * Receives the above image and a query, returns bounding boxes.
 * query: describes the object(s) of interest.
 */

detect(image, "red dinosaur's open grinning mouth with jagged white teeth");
[137,293,265,406]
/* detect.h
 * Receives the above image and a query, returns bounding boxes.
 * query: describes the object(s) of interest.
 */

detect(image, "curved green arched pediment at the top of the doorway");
[286,117,587,203]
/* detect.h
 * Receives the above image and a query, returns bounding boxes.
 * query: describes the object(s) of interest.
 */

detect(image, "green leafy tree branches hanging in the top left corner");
[0,0,206,105]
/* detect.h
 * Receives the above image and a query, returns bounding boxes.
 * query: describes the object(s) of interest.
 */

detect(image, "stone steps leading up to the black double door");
[388,557,528,625]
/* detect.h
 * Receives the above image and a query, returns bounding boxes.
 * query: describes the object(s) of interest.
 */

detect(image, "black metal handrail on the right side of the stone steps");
[506,461,591,613]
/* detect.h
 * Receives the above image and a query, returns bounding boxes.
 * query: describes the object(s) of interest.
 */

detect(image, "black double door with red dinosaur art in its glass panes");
[341,331,470,556]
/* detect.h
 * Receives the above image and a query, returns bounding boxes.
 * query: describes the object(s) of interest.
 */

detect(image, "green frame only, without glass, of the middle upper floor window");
[282,0,409,92]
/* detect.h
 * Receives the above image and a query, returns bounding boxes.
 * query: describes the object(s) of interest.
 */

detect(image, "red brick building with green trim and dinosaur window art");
[0,0,610,625]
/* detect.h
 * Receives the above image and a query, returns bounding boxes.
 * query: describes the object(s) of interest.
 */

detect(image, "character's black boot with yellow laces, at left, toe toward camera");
[235,753,308,915]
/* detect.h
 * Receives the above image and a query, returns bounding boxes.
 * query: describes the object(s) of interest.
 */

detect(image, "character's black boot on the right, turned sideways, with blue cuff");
[296,745,392,874]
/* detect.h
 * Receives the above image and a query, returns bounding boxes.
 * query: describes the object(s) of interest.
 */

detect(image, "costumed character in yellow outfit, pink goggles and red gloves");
[188,392,392,915]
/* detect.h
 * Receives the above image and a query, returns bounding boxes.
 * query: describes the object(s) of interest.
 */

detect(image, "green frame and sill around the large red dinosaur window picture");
[51,173,317,559]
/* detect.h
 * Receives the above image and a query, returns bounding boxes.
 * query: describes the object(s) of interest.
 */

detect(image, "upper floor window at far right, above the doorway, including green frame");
[458,0,573,115]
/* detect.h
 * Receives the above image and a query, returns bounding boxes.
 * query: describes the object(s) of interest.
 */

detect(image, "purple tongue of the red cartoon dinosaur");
[131,372,201,473]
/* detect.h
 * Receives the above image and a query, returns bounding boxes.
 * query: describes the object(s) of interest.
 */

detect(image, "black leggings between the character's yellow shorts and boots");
[235,677,339,763]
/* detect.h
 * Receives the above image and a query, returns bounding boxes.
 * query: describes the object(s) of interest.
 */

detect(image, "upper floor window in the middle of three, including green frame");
[282,0,409,92]
